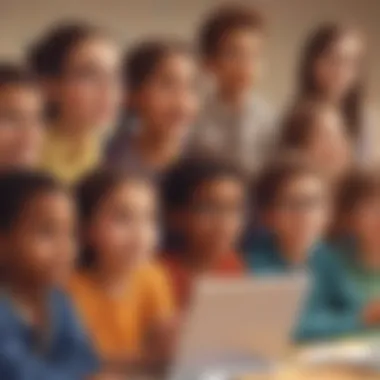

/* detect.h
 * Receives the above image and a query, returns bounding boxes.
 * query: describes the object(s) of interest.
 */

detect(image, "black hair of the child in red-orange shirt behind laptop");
[161,158,245,213]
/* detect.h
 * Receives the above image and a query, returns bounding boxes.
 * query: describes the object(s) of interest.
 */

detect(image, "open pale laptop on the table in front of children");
[169,273,308,380]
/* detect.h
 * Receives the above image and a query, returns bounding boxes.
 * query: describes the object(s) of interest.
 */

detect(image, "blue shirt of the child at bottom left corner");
[0,290,98,380]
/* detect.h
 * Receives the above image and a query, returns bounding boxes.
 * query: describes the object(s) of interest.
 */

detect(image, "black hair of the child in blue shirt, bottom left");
[0,170,65,232]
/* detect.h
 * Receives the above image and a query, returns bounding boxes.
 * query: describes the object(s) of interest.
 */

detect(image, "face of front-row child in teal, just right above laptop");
[268,175,329,251]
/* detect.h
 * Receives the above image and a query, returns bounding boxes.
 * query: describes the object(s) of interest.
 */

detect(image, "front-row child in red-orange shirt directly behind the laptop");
[163,160,245,309]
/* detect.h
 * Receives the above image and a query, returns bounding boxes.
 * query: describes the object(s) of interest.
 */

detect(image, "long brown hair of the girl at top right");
[298,23,363,138]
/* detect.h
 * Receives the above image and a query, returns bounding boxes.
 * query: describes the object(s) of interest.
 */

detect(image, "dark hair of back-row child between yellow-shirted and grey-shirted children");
[123,40,191,92]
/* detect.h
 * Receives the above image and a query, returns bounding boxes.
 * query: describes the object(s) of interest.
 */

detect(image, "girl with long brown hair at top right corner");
[298,24,376,163]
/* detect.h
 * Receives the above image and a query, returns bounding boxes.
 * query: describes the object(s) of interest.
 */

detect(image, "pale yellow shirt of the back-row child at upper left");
[40,130,102,185]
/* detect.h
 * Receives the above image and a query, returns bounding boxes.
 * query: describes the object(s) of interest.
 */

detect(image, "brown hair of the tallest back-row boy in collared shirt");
[199,5,264,58]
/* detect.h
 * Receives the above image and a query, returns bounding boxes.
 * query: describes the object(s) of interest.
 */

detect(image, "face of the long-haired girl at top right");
[314,34,364,99]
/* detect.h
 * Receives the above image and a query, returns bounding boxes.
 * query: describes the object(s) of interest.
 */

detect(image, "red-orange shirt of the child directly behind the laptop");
[162,253,245,309]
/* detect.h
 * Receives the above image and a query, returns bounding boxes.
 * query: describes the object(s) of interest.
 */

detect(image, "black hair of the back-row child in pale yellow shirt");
[28,22,104,78]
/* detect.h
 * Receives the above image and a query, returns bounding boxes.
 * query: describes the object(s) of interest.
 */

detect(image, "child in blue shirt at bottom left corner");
[0,171,98,380]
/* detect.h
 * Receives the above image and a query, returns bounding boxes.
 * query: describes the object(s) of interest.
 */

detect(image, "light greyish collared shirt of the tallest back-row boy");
[190,95,277,173]
